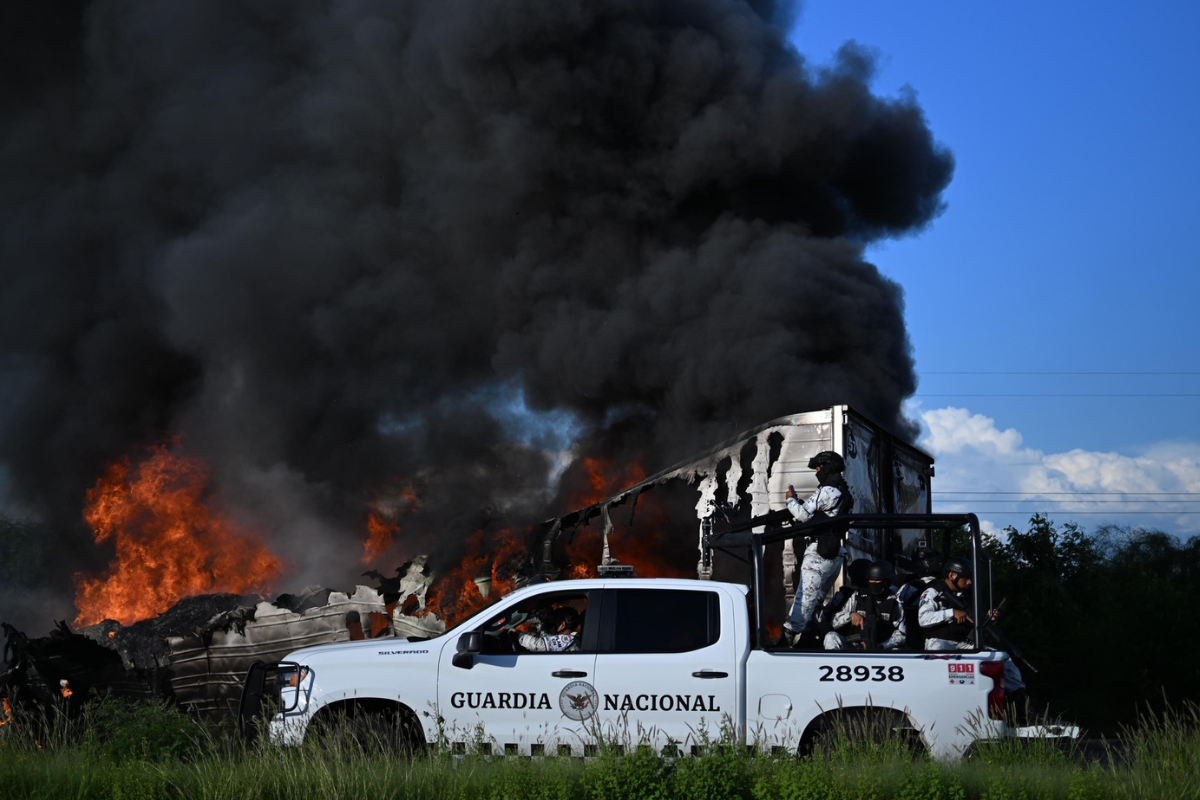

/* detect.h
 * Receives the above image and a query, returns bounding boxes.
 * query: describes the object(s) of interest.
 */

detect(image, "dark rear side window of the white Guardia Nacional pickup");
[606,589,721,652]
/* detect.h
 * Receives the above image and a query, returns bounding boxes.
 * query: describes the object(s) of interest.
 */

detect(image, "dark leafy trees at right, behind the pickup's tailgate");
[985,515,1200,732]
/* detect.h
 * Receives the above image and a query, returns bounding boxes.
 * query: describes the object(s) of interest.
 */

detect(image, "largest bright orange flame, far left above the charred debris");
[74,443,283,626]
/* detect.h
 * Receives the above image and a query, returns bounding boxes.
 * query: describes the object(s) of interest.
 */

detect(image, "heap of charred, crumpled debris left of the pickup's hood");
[0,557,446,723]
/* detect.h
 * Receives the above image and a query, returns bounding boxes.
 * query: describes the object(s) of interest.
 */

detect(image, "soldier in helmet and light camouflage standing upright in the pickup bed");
[784,450,854,644]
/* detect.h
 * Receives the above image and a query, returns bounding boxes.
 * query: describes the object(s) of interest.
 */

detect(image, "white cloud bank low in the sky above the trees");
[907,403,1200,535]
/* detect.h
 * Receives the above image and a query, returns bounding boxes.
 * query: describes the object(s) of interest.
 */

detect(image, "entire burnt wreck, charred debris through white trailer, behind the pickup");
[0,405,934,716]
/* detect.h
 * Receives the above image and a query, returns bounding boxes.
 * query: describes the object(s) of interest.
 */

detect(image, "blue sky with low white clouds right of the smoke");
[792,0,1200,534]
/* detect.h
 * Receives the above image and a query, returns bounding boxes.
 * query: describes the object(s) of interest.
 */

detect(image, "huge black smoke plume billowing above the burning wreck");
[0,0,953,633]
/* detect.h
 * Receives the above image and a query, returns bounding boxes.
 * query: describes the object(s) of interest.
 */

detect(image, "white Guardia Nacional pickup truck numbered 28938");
[242,535,1007,758]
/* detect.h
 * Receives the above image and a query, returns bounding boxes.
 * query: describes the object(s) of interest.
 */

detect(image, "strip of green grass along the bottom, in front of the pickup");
[0,700,1200,800]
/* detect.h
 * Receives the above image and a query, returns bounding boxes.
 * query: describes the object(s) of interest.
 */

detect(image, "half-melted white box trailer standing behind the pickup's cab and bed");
[541,405,934,602]
